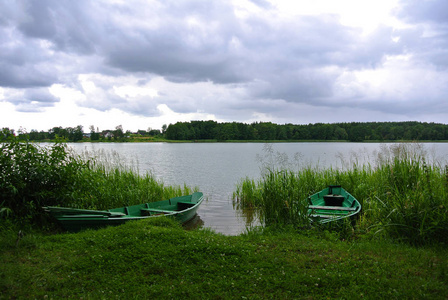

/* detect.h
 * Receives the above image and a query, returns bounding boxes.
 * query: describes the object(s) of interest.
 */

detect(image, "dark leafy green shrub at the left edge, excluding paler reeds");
[0,139,88,219]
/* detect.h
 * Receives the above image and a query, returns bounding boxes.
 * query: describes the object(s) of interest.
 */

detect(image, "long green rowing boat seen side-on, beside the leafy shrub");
[43,192,204,232]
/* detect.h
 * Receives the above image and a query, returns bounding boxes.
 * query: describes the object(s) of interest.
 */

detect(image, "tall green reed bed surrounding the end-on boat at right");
[233,144,448,245]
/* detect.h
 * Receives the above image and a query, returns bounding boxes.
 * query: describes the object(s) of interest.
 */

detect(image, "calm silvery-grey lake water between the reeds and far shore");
[69,143,448,235]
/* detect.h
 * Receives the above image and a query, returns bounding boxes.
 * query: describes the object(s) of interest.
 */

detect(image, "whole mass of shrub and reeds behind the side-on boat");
[0,136,191,224]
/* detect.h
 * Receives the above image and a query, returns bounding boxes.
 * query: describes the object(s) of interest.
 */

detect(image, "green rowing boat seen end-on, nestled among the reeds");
[308,185,361,223]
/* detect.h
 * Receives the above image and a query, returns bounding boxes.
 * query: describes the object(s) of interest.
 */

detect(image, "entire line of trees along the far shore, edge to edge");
[0,120,448,142]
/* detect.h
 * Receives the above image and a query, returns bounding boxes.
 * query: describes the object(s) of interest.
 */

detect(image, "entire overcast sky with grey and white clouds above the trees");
[0,0,448,132]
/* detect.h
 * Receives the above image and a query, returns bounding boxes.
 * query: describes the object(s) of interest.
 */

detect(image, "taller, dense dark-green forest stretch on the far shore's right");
[165,121,448,142]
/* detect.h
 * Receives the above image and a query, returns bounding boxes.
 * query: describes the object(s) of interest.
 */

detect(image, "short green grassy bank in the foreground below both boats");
[0,218,448,299]
